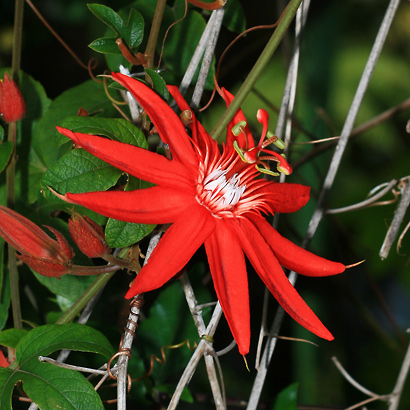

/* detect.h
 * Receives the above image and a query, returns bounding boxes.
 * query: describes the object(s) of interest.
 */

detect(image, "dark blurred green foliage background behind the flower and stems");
[0,0,410,410]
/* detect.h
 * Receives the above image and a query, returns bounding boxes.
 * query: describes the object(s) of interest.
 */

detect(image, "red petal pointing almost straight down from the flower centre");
[205,219,251,355]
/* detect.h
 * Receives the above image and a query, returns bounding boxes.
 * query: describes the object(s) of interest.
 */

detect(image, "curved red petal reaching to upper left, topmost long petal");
[112,73,198,167]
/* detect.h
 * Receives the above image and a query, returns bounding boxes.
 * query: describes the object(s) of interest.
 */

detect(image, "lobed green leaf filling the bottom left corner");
[0,323,114,410]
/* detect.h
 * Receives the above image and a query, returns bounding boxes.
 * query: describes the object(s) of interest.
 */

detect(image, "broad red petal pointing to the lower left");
[125,204,215,299]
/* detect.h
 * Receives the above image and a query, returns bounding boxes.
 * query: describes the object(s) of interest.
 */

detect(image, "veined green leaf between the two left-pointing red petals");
[41,149,122,197]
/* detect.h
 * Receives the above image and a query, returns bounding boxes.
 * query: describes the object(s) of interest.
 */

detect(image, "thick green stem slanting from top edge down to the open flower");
[211,0,302,139]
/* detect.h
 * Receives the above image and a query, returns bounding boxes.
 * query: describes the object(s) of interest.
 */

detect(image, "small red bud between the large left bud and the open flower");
[68,212,111,258]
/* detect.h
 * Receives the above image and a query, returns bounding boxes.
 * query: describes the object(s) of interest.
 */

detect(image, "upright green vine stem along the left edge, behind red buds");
[6,0,24,329]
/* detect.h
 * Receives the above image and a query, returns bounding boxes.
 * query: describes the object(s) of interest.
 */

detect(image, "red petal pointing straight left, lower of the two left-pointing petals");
[63,187,197,224]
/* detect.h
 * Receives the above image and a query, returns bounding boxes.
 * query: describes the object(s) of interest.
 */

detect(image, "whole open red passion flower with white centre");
[53,73,345,355]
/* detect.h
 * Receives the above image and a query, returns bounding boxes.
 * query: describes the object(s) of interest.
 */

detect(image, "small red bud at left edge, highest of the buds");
[0,73,26,122]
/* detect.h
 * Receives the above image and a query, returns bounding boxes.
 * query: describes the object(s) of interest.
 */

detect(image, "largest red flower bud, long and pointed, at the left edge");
[0,205,74,277]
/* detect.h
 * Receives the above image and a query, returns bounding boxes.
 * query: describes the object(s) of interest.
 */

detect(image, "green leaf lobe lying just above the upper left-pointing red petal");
[62,116,148,148]
